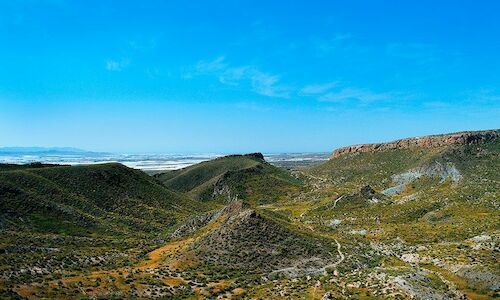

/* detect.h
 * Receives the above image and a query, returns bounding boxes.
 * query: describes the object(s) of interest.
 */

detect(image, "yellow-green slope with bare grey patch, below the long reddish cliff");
[305,139,500,242]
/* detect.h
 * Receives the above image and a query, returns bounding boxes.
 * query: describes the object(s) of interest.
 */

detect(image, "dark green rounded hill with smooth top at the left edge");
[0,164,205,234]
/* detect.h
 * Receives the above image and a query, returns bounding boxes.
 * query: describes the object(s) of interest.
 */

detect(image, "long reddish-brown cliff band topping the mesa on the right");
[330,129,500,159]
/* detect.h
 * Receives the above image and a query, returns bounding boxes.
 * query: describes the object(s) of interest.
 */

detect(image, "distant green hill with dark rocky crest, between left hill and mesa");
[155,153,301,204]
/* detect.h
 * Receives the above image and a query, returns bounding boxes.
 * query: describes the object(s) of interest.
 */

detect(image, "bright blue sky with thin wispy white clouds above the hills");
[0,0,500,153]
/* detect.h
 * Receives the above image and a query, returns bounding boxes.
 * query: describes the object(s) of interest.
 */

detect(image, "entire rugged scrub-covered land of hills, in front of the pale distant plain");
[0,130,500,299]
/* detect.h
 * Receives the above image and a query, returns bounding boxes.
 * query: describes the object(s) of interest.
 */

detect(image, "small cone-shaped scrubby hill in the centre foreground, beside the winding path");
[188,209,339,276]
